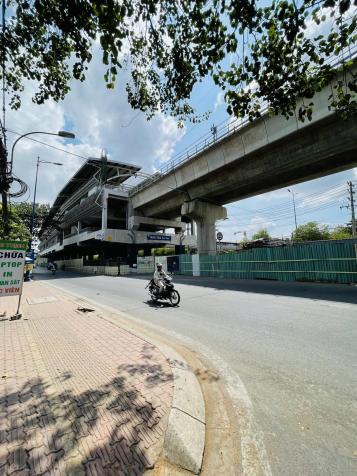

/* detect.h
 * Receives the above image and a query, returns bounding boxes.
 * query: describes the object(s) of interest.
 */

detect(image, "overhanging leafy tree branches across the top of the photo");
[1,0,357,120]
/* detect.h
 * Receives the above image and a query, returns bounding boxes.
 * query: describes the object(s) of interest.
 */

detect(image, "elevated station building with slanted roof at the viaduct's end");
[39,158,196,264]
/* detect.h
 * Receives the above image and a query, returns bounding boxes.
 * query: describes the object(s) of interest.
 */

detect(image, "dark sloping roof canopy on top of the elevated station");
[40,158,141,235]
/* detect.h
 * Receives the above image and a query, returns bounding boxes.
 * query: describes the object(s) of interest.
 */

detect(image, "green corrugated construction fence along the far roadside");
[180,239,357,283]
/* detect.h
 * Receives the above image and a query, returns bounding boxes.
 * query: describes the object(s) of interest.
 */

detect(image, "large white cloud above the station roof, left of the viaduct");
[7,45,185,202]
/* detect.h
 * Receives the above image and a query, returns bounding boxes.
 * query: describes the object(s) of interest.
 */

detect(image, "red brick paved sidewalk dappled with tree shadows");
[0,282,173,476]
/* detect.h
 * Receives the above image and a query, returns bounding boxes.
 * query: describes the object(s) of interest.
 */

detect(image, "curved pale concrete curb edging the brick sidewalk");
[41,282,206,474]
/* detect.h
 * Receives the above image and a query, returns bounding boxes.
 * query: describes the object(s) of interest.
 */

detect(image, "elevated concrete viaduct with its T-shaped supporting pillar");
[130,65,357,253]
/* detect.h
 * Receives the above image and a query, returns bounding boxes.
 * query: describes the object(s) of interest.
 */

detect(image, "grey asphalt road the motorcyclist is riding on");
[37,273,357,476]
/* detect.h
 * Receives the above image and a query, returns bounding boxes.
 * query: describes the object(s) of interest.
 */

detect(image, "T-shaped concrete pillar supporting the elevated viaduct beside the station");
[181,200,227,254]
